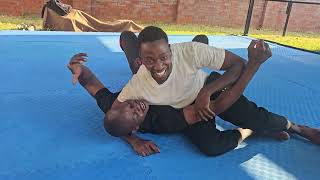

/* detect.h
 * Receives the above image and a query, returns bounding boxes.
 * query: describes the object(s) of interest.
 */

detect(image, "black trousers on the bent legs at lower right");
[183,72,288,156]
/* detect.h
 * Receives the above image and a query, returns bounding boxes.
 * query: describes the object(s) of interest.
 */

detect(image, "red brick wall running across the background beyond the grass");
[0,0,320,32]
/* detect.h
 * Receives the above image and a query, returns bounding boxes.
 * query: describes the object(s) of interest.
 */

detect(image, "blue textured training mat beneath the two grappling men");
[0,31,320,180]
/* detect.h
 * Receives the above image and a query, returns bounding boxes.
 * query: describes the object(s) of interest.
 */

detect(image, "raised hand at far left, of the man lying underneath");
[68,53,87,84]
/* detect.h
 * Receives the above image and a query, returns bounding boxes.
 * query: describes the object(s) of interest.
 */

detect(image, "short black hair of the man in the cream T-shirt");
[138,26,169,49]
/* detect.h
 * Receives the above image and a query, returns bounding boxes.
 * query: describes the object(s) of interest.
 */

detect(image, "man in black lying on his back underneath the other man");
[69,30,315,155]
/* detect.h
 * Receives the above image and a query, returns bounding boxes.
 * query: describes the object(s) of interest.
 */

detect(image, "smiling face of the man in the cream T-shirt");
[140,39,172,84]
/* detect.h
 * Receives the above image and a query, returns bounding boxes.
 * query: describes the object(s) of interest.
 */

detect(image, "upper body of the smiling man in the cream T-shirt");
[113,26,244,119]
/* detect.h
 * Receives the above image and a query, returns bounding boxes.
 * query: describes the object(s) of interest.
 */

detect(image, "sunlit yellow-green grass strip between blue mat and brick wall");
[0,15,320,52]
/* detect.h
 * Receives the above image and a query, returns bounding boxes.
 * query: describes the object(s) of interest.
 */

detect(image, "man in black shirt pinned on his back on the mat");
[68,36,319,156]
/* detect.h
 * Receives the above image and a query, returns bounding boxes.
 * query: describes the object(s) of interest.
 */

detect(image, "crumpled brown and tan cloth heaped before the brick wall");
[43,7,143,32]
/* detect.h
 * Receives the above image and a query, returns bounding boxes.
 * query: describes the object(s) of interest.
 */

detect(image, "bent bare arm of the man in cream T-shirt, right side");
[194,51,244,120]
